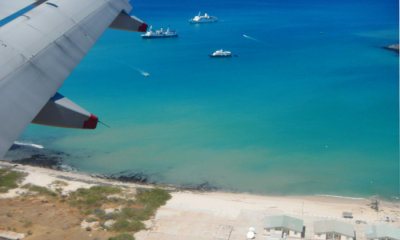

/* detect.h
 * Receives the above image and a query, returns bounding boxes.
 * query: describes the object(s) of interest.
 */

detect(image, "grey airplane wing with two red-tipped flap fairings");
[0,0,147,157]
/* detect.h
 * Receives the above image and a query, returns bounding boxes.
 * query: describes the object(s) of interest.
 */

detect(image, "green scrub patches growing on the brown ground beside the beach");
[0,169,171,235]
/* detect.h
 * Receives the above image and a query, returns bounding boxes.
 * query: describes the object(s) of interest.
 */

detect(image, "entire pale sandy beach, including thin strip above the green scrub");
[0,162,400,240]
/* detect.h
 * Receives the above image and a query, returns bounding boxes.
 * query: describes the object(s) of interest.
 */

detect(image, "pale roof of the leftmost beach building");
[264,215,303,232]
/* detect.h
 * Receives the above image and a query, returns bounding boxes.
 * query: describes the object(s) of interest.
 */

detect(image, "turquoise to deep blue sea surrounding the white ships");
[7,0,399,198]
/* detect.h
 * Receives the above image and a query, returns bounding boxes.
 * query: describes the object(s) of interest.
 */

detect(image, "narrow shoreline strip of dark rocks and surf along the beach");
[6,141,400,202]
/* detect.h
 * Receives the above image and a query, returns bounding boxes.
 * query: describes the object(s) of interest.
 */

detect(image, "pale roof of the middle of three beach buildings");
[314,220,354,237]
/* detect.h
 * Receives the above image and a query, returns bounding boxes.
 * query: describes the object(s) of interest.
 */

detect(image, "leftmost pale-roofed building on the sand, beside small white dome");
[264,215,304,239]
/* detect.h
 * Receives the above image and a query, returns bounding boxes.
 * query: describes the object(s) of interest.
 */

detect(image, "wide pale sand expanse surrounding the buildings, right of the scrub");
[135,192,400,240]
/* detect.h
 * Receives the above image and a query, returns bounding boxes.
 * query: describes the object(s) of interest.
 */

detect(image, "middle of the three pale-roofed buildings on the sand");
[313,220,356,240]
